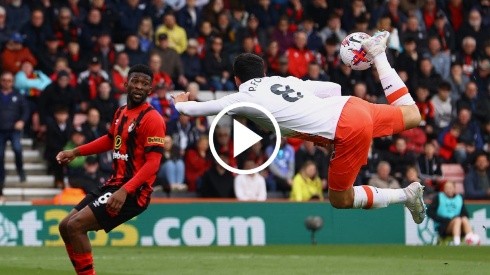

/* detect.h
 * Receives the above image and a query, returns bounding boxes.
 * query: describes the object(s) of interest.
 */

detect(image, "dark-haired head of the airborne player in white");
[233,53,265,82]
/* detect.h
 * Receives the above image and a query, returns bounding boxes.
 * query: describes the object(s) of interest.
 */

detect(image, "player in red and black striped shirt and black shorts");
[56,65,165,275]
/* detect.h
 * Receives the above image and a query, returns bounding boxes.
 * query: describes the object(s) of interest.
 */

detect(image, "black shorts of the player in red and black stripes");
[75,186,148,233]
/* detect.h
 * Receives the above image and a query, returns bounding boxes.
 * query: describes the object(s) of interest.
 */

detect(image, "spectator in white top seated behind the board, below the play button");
[233,159,267,201]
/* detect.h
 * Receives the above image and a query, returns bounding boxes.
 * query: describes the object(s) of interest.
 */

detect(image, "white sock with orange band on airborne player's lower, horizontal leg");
[352,185,407,209]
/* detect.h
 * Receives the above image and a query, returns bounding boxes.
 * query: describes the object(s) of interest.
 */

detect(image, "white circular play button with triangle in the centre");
[209,102,281,174]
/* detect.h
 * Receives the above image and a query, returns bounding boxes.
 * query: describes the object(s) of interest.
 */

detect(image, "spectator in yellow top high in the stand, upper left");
[155,12,187,54]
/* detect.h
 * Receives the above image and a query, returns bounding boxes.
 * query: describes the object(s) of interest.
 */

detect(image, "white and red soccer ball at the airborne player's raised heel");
[340,32,373,71]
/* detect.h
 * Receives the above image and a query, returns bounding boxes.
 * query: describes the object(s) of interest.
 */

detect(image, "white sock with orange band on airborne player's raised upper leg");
[379,67,415,106]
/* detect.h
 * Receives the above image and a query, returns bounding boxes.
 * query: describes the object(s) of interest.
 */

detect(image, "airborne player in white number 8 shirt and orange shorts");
[174,31,426,224]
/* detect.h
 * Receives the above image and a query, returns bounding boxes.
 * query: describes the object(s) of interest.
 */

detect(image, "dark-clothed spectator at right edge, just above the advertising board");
[464,153,490,200]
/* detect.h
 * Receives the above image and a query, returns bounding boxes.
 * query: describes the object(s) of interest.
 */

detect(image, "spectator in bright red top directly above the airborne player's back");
[285,31,314,78]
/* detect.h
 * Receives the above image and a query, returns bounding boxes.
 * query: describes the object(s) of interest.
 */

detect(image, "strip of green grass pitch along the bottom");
[0,245,490,275]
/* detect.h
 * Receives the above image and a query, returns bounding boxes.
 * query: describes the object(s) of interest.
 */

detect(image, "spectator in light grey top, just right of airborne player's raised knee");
[431,81,453,133]
